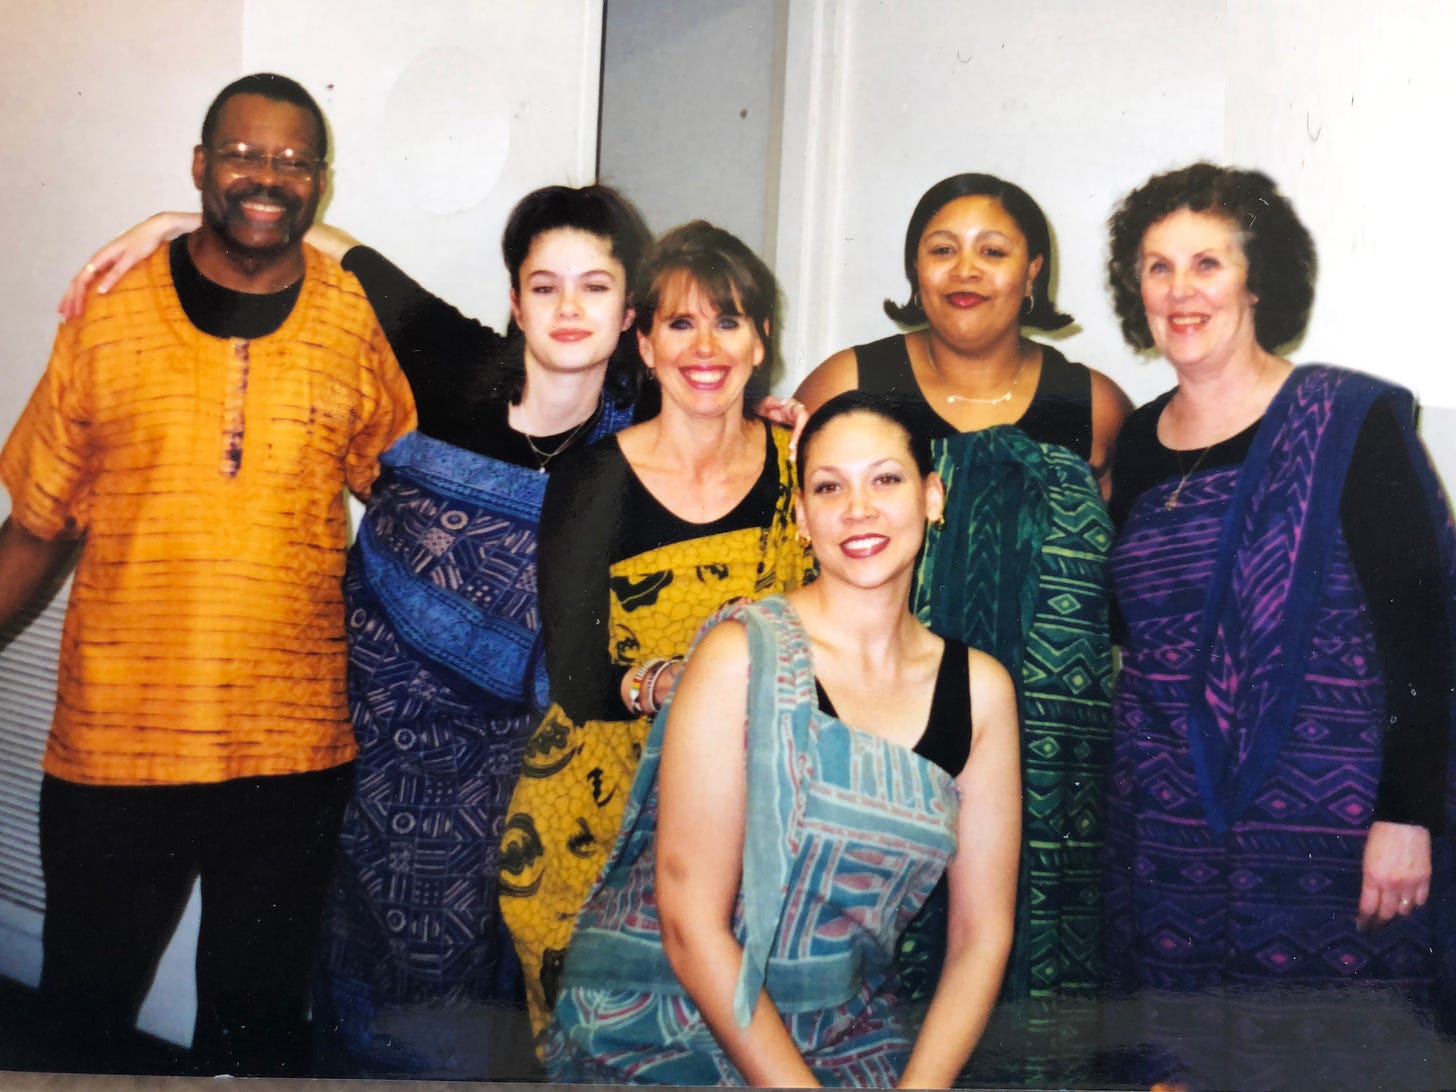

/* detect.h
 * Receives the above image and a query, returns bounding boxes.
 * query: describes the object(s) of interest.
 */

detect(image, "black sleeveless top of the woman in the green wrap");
[855,333,1092,462]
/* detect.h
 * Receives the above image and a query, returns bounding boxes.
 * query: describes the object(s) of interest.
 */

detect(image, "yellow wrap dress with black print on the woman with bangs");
[501,430,812,1035]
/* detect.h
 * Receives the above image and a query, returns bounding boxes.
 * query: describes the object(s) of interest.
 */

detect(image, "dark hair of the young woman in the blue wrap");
[496,185,652,406]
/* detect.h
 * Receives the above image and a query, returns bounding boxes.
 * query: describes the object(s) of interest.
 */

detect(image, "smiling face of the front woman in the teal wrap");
[798,411,945,588]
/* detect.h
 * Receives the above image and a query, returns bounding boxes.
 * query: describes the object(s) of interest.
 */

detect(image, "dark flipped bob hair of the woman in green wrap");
[885,175,1072,331]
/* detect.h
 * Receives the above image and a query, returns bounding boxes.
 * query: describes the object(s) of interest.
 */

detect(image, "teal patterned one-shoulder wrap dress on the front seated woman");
[546,596,960,1086]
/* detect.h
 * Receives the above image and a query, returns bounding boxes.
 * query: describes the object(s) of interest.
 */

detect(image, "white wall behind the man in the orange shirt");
[0,0,601,1042]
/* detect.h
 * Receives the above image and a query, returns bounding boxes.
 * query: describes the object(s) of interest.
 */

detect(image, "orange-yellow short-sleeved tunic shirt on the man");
[0,248,415,785]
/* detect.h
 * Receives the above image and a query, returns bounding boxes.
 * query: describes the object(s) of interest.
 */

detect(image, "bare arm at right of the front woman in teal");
[900,649,1021,1088]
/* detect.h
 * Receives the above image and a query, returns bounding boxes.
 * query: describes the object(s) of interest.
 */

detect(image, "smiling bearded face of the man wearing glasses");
[192,95,328,258]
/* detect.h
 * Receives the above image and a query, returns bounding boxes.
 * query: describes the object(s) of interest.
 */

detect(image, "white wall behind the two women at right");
[778,0,1456,454]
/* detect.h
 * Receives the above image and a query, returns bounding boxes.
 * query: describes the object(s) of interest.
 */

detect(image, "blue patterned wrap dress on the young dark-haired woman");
[316,405,630,1079]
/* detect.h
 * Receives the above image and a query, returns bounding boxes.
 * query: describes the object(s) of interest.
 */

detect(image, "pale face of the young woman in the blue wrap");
[511,227,632,381]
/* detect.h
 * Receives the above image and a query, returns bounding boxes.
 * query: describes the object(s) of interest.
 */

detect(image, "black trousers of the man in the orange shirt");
[41,763,354,1076]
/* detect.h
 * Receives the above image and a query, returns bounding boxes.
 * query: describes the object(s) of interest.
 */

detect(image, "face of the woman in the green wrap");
[916,197,1044,351]
